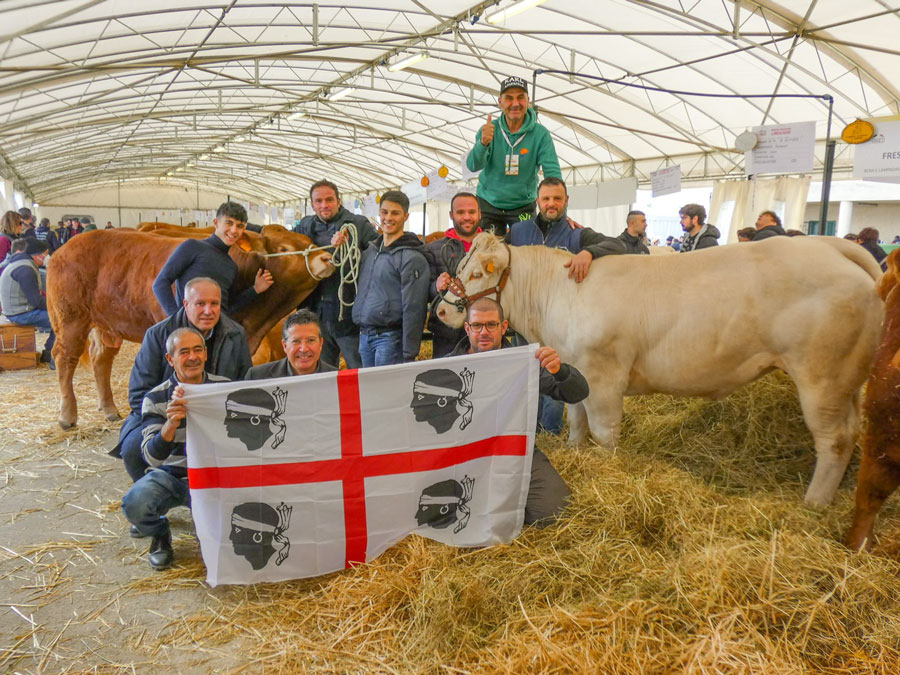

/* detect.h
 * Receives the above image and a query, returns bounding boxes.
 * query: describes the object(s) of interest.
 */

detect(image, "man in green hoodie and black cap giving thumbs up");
[466,77,562,236]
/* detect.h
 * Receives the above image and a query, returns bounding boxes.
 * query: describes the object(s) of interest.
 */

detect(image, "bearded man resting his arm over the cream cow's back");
[504,177,625,283]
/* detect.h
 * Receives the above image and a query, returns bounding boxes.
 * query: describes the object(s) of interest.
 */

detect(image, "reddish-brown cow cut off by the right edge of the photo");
[846,249,900,550]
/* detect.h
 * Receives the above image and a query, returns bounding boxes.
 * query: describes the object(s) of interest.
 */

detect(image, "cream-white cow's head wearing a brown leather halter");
[435,232,509,328]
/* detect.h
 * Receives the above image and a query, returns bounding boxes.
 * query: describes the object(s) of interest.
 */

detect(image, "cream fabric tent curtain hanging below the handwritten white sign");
[708,176,810,244]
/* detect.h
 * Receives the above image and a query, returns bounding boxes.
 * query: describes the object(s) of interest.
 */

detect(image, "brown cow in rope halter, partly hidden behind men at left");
[47,226,334,429]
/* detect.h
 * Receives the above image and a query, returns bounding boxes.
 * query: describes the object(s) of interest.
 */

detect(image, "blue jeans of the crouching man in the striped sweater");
[122,469,191,537]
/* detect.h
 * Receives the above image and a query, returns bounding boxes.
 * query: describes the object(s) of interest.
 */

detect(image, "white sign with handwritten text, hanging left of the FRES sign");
[744,122,816,176]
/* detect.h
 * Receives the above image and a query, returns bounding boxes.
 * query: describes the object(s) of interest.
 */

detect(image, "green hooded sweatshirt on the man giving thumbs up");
[466,108,562,209]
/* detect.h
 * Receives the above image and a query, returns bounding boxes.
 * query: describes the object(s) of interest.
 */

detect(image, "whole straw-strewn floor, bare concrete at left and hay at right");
[0,345,900,675]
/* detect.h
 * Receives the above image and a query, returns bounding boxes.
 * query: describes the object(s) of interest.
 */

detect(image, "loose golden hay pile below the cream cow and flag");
[131,375,900,675]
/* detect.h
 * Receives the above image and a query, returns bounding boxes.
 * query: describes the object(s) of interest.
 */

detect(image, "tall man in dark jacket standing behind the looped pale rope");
[294,180,378,368]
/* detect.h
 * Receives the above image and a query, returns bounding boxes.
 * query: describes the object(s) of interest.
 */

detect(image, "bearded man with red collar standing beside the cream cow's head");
[425,192,481,359]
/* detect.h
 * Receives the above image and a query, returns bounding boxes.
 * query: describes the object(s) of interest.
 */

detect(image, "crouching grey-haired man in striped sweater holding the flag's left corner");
[122,328,229,570]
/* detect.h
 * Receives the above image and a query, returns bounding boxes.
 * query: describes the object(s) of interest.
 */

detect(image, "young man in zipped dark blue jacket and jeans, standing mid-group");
[344,191,429,368]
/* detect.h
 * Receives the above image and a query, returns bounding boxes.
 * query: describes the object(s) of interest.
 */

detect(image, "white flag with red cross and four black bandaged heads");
[185,345,539,586]
